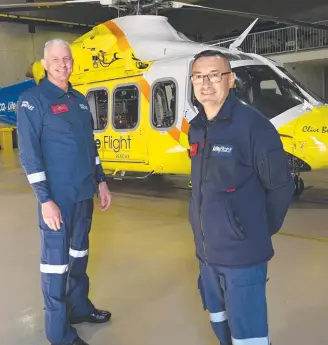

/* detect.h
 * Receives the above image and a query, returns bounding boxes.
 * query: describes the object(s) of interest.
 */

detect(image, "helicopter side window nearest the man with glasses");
[152,80,177,128]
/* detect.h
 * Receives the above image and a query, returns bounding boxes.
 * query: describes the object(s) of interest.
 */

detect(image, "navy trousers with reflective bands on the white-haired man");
[38,199,94,345]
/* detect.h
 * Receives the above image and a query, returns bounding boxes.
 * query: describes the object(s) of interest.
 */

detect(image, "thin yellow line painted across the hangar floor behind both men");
[0,183,328,243]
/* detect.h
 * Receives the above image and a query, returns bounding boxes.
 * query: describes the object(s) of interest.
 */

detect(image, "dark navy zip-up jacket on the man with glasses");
[189,91,294,267]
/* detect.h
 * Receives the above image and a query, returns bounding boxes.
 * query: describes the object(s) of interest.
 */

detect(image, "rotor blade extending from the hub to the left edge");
[0,0,116,12]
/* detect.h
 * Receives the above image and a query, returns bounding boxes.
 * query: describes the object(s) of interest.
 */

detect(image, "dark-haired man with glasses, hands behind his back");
[189,50,294,345]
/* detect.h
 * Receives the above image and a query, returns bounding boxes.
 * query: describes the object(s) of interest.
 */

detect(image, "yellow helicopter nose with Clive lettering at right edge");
[294,105,328,170]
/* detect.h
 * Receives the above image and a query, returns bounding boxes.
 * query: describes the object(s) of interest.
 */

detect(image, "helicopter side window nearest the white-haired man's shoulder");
[87,89,108,131]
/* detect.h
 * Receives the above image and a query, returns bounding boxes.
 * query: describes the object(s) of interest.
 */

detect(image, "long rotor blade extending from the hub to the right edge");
[170,1,328,31]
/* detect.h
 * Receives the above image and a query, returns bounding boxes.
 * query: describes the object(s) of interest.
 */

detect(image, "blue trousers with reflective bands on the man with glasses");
[198,263,270,345]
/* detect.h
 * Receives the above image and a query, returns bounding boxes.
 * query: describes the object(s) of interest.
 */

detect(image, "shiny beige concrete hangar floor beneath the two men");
[0,150,328,345]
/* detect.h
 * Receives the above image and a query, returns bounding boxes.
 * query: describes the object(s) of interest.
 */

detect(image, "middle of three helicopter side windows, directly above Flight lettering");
[113,85,139,130]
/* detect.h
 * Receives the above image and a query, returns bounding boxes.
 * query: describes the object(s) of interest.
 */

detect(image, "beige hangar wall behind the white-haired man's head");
[0,22,80,87]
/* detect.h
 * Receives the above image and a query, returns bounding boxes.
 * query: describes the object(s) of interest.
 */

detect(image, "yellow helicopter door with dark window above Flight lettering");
[103,84,148,164]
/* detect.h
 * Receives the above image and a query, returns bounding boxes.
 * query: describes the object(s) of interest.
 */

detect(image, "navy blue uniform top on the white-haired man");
[17,79,104,205]
